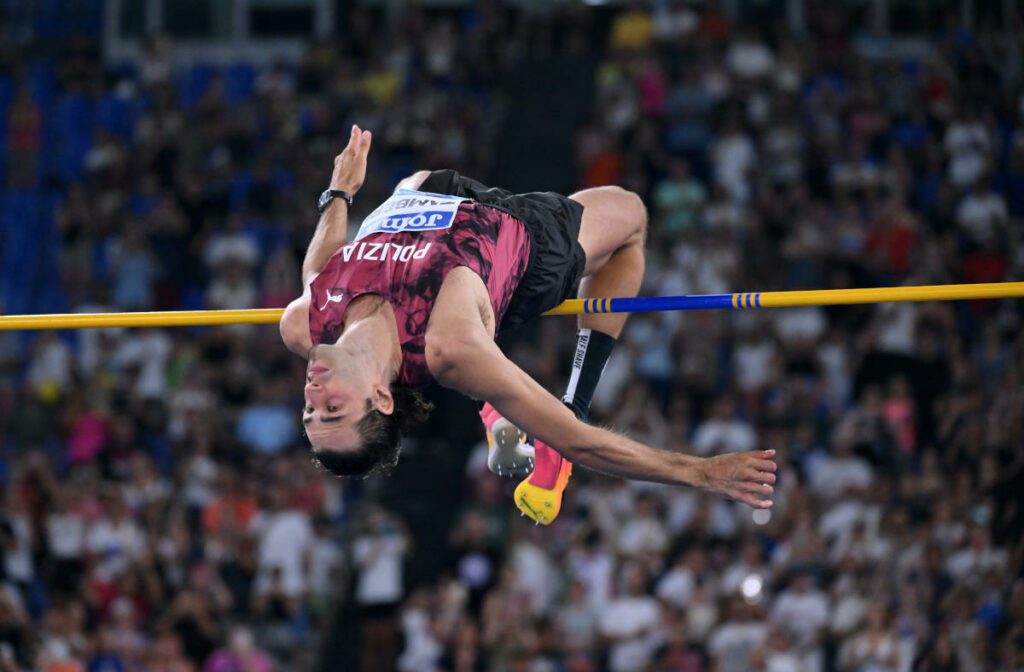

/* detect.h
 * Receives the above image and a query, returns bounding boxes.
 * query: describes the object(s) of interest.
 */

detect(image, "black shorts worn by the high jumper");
[419,170,587,329]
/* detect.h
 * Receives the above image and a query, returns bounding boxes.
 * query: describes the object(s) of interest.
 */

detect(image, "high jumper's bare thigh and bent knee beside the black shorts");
[569,186,647,276]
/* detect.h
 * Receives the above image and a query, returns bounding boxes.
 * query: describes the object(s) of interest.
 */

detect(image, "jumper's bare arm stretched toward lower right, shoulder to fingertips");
[426,327,775,508]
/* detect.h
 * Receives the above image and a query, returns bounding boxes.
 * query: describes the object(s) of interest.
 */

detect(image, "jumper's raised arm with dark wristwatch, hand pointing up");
[280,126,373,358]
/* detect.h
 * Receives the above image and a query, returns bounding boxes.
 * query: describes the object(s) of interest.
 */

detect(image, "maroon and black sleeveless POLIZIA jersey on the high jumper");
[309,197,529,387]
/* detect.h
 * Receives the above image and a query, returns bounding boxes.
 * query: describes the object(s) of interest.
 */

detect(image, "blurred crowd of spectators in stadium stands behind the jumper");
[0,2,1024,672]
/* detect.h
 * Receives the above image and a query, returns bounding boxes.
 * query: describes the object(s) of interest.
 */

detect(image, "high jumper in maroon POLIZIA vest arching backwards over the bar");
[281,126,775,524]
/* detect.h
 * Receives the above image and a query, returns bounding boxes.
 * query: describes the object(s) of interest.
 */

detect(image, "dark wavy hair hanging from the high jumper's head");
[313,383,433,478]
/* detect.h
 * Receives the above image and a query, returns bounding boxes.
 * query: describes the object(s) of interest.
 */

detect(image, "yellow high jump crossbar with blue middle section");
[0,282,1024,331]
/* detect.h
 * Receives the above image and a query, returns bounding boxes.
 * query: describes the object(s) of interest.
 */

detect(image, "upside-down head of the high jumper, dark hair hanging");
[302,353,430,477]
